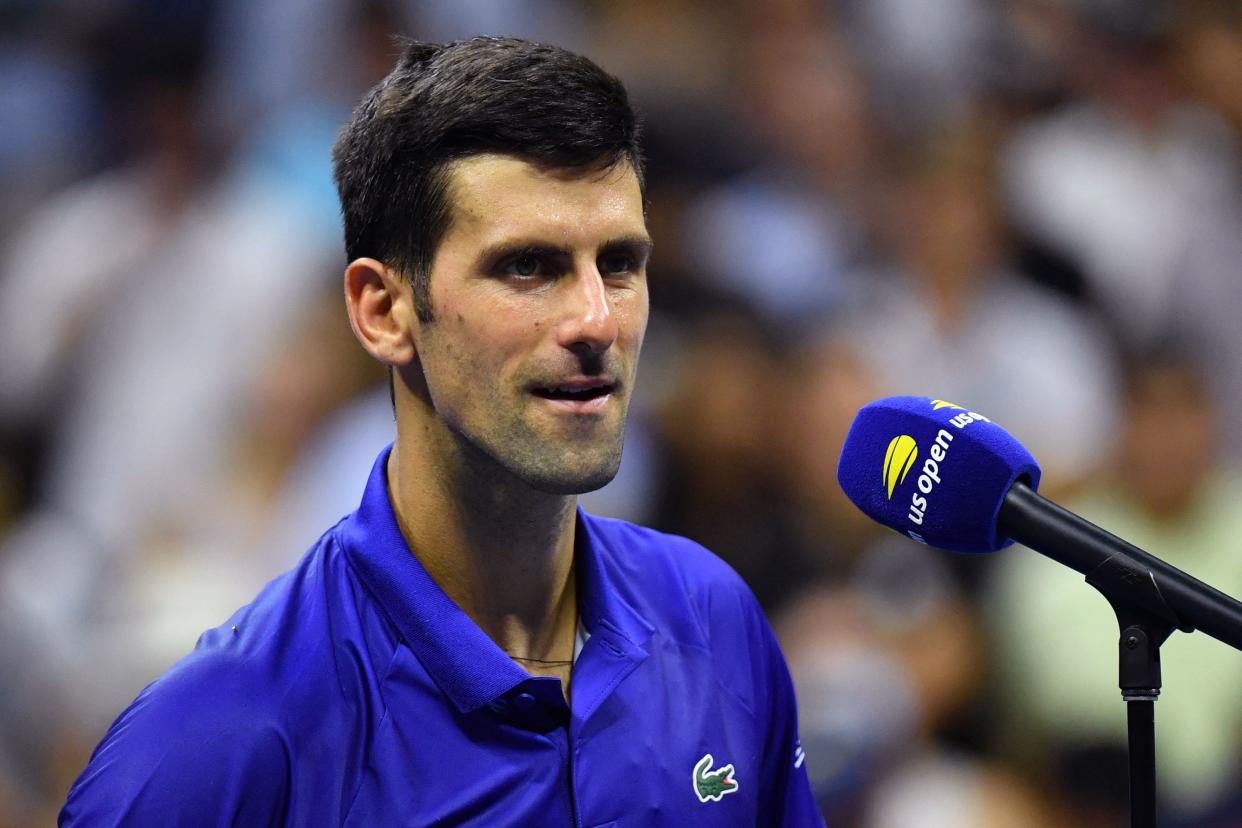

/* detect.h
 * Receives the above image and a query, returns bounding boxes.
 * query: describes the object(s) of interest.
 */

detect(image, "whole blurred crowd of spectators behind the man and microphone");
[0,0,1242,828]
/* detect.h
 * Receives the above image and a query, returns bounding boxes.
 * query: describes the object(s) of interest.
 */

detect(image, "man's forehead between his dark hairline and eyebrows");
[445,155,646,245]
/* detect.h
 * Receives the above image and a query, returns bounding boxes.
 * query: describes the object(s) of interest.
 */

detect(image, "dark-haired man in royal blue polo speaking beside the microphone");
[62,38,821,826]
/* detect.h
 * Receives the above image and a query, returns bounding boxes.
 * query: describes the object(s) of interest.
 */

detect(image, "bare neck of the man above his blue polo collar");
[388,437,578,677]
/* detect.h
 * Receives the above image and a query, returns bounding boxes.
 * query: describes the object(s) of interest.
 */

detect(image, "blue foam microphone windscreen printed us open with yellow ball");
[837,397,1040,552]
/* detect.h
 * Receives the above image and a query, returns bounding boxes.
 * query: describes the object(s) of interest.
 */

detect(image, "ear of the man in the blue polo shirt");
[345,258,419,369]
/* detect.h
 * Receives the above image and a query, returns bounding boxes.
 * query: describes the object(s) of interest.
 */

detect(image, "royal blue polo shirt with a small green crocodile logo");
[60,449,822,828]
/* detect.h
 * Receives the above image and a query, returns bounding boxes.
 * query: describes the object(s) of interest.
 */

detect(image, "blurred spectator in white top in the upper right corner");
[1004,4,1237,344]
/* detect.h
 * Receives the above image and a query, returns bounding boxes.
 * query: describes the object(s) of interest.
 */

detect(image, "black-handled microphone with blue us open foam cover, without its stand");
[837,397,1242,649]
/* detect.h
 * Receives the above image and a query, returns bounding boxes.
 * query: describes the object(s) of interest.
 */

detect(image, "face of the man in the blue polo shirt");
[416,155,651,494]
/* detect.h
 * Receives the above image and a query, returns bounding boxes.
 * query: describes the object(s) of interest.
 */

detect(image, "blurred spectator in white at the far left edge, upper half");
[0,67,215,426]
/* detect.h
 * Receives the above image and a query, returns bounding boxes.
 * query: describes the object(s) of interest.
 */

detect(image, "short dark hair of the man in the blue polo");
[333,37,645,322]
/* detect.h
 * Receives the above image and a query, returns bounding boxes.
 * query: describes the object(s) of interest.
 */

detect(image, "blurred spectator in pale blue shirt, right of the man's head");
[683,11,878,326]
